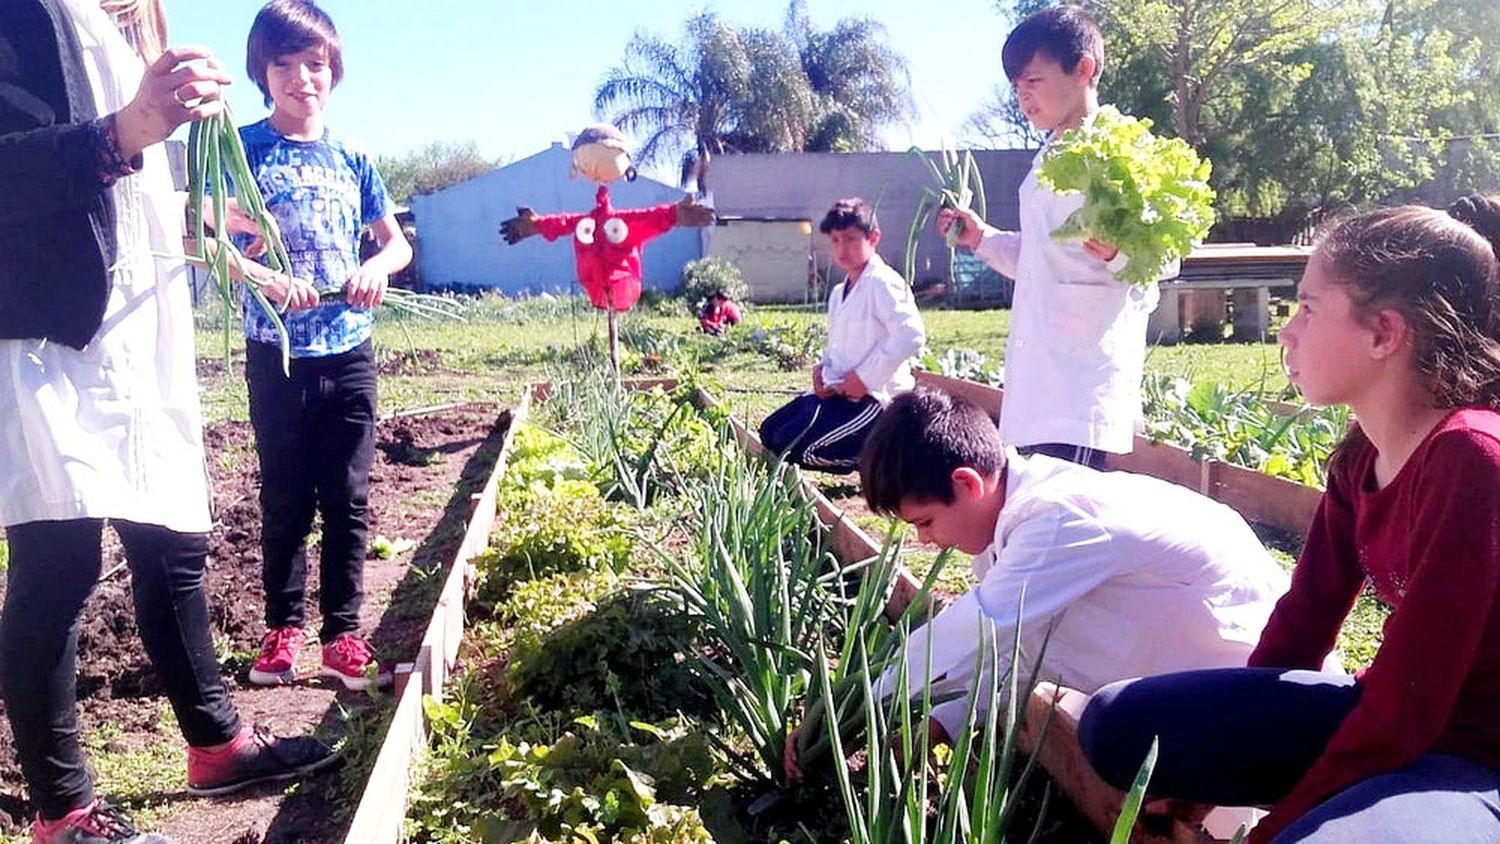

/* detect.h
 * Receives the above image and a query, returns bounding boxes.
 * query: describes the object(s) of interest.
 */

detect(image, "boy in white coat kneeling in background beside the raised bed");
[761,199,927,474]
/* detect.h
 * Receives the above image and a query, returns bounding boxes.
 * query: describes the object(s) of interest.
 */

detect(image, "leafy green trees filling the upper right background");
[975,0,1500,216]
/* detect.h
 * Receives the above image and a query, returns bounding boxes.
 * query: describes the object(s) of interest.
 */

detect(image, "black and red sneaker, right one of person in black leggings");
[188,727,339,798]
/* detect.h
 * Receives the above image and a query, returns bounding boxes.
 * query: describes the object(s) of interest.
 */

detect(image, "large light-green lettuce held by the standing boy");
[1038,106,1214,285]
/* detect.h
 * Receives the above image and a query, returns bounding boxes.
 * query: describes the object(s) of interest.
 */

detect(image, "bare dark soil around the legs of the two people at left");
[0,405,510,844]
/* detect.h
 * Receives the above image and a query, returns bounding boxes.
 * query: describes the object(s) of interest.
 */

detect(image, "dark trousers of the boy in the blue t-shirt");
[245,340,375,643]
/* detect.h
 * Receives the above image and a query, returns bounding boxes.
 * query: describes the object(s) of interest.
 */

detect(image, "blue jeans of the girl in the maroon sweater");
[1079,669,1500,844]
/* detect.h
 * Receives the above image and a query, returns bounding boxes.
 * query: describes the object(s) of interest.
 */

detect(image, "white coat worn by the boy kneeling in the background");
[821,255,927,405]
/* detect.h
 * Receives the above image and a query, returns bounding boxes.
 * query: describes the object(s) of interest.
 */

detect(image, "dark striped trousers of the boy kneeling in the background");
[761,393,884,474]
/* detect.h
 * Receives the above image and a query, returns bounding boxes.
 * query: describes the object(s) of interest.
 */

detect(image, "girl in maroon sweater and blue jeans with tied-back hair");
[1080,196,1500,843]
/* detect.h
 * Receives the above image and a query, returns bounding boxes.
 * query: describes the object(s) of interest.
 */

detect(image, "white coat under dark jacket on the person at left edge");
[0,0,210,532]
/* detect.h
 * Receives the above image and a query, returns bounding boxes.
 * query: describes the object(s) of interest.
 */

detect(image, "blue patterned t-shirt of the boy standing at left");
[236,120,390,357]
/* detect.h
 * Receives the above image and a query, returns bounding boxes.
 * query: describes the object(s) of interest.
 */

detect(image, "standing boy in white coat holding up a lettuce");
[938,6,1176,469]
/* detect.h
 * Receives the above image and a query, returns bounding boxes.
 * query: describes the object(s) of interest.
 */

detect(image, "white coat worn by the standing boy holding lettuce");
[974,148,1176,453]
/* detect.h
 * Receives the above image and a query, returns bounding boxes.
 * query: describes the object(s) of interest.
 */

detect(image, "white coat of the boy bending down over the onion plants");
[882,452,1338,736]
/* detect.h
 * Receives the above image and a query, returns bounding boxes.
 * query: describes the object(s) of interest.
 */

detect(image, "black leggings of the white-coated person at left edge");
[0,519,240,819]
